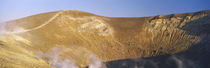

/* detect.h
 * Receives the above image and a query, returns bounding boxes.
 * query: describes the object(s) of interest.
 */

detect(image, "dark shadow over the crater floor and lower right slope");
[86,12,210,68]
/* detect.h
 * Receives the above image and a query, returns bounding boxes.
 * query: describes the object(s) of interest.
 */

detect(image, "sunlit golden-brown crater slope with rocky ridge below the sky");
[0,10,210,68]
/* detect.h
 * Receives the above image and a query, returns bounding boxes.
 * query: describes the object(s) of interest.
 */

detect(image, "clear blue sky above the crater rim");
[0,0,210,22]
